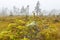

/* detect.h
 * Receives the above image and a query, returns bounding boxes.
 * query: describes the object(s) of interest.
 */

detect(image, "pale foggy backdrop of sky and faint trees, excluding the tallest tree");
[0,0,60,15]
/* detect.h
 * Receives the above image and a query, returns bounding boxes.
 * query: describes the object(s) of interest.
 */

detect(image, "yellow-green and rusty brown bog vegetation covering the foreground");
[0,16,60,40]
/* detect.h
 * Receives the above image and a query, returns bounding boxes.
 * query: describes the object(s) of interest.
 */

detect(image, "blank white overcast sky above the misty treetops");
[0,0,60,11]
